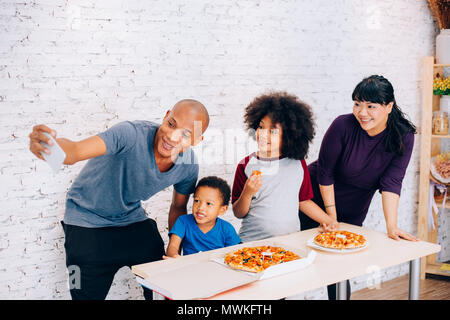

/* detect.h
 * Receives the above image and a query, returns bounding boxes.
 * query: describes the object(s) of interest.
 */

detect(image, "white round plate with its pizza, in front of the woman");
[307,230,368,253]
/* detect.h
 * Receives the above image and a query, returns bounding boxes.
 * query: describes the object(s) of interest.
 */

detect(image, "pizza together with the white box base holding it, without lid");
[212,243,316,279]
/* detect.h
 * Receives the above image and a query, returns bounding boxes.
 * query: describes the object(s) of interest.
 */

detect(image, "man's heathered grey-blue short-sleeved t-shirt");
[64,121,198,228]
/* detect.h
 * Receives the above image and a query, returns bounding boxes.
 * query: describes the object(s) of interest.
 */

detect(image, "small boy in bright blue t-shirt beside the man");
[166,176,241,258]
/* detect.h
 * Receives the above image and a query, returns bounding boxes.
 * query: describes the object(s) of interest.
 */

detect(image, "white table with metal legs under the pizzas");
[132,223,441,300]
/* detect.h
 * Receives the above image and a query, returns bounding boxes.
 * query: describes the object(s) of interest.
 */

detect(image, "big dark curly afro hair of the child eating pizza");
[244,91,315,160]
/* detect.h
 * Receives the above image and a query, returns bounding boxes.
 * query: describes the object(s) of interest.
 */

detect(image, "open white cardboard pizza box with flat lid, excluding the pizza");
[132,240,316,300]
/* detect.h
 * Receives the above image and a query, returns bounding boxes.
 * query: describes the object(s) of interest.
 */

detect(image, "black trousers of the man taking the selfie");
[61,219,164,300]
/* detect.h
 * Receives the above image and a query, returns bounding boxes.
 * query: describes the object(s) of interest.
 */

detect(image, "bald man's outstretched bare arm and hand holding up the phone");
[29,125,106,164]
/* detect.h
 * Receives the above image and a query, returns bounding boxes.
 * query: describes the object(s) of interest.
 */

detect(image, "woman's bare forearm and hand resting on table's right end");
[381,191,419,241]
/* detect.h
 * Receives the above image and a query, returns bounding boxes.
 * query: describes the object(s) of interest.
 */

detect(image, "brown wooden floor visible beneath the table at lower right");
[350,275,450,300]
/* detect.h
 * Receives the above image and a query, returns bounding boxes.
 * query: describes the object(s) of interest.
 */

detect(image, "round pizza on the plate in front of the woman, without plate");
[314,231,366,250]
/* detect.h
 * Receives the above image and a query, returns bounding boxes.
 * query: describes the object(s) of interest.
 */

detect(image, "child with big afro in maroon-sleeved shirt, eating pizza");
[232,92,335,242]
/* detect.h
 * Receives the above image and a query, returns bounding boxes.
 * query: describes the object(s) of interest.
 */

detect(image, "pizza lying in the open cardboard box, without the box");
[224,246,300,272]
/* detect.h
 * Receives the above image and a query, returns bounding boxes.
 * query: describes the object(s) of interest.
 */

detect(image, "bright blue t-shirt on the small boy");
[169,214,241,255]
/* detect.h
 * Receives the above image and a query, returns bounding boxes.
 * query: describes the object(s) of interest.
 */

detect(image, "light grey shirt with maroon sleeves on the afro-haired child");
[232,153,313,242]
